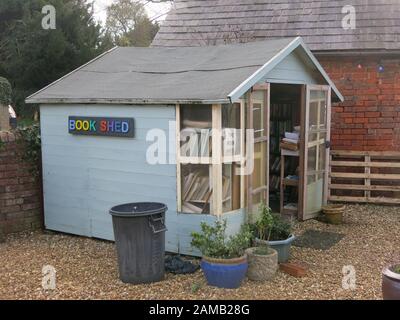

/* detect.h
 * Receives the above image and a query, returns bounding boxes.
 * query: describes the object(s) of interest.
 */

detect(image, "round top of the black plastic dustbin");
[110,202,168,217]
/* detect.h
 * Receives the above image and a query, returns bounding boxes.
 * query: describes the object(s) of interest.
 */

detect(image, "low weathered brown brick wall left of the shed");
[0,132,42,237]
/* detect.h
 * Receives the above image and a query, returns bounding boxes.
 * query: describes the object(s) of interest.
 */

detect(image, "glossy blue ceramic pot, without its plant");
[200,256,248,289]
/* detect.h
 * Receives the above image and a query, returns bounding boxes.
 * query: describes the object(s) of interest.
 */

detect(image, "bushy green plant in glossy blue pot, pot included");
[191,220,252,289]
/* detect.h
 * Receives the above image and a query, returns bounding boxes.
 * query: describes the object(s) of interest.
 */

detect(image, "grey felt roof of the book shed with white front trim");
[26,38,342,104]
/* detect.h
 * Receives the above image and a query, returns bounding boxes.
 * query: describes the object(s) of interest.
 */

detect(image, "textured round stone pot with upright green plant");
[246,204,278,281]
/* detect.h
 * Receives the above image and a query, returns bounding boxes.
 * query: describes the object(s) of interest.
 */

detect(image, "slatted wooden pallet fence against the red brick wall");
[329,151,400,204]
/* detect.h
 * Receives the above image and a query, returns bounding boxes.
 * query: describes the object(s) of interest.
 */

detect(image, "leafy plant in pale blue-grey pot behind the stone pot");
[255,204,296,263]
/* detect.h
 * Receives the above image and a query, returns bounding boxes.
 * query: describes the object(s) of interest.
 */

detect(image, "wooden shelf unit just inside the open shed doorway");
[280,149,300,216]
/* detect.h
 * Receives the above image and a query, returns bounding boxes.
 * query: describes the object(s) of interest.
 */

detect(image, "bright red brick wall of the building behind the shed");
[318,56,400,151]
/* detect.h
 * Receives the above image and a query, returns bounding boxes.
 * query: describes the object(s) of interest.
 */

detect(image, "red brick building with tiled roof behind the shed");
[153,0,400,151]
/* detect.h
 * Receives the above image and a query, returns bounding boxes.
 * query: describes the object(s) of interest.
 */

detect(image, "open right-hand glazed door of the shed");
[299,85,331,220]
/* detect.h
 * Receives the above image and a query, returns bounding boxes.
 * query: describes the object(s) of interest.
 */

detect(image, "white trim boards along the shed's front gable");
[228,37,344,102]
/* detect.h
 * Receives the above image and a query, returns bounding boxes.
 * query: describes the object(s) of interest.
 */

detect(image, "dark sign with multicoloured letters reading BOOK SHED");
[68,116,134,138]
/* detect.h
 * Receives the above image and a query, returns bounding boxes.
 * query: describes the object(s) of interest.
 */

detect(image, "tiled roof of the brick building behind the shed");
[153,0,400,51]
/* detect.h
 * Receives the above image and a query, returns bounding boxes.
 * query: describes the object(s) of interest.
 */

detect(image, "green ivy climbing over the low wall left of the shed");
[17,124,41,178]
